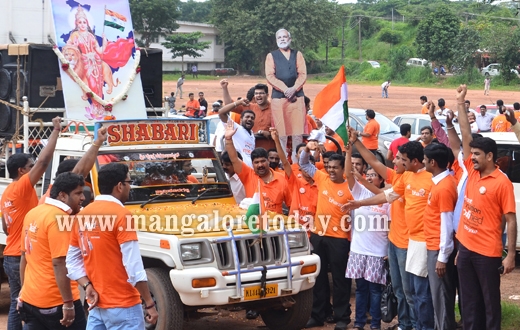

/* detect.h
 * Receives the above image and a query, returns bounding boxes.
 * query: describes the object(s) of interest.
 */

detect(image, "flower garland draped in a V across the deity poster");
[52,45,141,112]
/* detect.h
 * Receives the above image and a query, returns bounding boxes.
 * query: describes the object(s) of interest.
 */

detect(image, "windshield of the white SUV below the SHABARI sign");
[96,148,232,204]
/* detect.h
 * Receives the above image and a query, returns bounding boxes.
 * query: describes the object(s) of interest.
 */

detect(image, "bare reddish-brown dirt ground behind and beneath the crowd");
[0,76,520,330]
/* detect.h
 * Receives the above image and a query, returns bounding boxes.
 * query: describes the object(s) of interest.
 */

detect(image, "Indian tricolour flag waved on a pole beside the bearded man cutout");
[312,66,348,144]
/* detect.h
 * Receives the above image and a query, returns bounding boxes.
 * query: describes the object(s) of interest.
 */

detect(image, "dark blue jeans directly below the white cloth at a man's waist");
[409,273,435,330]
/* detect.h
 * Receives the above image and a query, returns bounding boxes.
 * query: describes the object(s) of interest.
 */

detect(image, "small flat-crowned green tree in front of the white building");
[162,31,211,73]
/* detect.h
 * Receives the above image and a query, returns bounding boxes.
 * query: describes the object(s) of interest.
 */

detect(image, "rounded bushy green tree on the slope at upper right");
[415,5,460,64]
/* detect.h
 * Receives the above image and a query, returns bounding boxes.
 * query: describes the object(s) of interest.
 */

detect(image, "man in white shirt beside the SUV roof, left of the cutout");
[218,99,256,166]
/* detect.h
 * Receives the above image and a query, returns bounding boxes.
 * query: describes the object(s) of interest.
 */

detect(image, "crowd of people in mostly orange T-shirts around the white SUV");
[1,80,520,330]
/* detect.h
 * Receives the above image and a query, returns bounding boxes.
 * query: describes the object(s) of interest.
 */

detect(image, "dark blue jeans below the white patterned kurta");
[354,278,383,329]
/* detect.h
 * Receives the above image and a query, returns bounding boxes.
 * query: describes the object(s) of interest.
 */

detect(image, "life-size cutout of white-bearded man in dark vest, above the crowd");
[265,29,307,160]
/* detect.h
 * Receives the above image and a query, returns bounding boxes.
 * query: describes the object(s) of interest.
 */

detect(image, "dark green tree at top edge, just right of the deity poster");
[130,0,179,47]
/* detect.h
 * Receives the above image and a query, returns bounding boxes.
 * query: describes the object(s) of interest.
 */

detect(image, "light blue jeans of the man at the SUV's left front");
[87,304,144,330]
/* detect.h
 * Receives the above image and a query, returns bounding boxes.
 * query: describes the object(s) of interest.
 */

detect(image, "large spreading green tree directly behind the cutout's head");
[211,0,337,73]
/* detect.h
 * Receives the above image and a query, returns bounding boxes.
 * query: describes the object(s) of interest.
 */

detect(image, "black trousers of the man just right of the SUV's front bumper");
[311,233,352,323]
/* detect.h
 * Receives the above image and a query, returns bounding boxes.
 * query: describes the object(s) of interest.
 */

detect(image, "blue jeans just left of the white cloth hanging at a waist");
[388,242,415,330]
